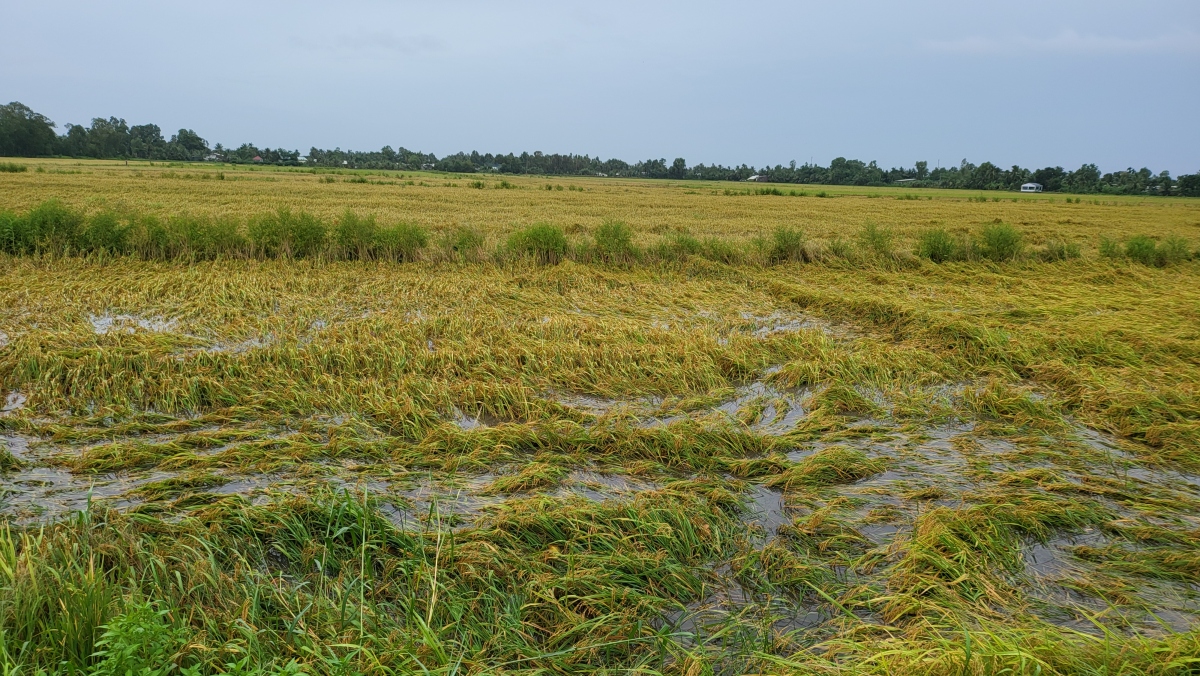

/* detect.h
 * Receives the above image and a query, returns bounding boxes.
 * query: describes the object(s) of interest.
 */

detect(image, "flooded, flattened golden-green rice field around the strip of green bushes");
[0,160,1200,676]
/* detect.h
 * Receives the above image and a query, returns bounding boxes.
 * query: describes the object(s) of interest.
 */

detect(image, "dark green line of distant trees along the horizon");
[0,102,1200,197]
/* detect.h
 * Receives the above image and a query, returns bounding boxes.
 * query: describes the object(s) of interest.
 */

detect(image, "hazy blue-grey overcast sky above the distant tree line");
[7,0,1200,174]
